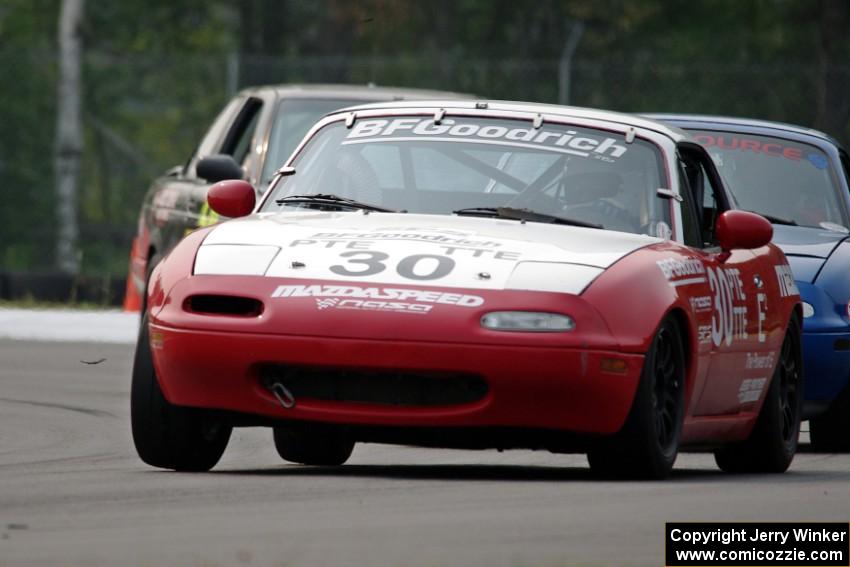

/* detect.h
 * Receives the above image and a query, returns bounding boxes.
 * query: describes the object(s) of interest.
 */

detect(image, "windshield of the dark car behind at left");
[262,99,365,184]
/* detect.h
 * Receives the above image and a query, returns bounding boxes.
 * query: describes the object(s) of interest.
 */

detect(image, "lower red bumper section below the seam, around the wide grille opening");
[150,324,643,433]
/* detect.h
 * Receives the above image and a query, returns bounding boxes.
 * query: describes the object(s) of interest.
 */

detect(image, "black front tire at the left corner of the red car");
[130,314,233,471]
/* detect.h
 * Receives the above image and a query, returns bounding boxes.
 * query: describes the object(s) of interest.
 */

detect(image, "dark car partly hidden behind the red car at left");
[124,85,469,311]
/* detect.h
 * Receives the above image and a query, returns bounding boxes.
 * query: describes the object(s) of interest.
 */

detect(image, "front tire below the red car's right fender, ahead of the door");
[587,317,687,479]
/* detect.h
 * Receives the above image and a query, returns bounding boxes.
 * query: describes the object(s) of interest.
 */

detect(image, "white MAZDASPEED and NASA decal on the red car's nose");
[271,285,484,315]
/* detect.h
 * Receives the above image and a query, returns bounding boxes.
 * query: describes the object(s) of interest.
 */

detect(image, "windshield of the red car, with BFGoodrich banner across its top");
[262,116,669,235]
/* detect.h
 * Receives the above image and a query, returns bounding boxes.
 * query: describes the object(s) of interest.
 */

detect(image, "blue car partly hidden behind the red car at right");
[651,114,850,451]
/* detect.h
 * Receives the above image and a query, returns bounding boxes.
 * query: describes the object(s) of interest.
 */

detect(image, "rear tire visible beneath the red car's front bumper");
[274,423,354,466]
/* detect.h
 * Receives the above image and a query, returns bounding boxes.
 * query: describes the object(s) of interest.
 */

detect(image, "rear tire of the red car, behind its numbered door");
[714,315,803,473]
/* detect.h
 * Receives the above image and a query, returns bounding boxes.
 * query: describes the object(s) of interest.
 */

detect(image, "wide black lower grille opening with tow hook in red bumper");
[260,364,487,407]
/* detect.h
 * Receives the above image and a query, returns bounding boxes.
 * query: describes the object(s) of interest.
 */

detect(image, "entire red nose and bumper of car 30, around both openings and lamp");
[150,276,644,434]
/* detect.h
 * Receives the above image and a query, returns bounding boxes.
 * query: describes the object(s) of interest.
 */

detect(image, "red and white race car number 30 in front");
[132,101,803,478]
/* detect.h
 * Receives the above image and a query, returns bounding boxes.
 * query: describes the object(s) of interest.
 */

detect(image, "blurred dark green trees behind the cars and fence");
[0,0,850,274]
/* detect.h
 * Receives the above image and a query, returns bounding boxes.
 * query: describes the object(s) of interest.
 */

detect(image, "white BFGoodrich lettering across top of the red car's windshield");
[342,117,628,161]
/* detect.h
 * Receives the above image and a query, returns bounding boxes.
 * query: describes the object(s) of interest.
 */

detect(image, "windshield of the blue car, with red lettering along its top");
[693,130,850,232]
